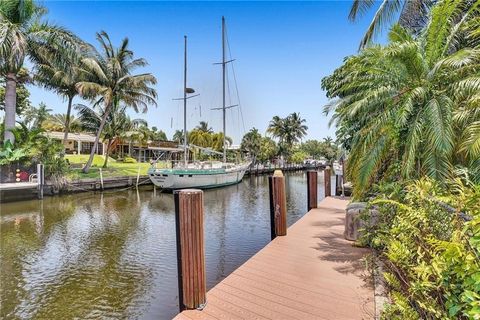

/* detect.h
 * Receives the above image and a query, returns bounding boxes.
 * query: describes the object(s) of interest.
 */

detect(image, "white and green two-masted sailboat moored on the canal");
[148,17,251,190]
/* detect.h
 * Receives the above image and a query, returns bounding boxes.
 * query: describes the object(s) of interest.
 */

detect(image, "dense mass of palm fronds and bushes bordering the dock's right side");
[322,0,480,320]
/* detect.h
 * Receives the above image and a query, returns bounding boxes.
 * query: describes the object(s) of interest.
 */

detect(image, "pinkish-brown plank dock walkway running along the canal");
[175,197,374,320]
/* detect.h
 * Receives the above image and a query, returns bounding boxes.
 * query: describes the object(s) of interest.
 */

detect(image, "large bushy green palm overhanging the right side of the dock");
[322,1,480,197]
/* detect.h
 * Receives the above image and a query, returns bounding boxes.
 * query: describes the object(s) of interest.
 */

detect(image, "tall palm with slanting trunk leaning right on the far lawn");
[77,31,157,173]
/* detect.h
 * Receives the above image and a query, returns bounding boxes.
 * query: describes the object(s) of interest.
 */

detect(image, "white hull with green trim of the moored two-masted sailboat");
[148,165,248,190]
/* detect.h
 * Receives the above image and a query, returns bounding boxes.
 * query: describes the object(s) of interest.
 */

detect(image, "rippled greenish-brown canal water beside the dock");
[0,172,324,320]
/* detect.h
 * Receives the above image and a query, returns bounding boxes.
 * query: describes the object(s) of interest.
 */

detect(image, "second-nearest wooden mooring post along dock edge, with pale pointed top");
[268,170,287,240]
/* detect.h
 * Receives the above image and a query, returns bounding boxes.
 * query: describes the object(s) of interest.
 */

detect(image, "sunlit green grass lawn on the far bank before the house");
[65,154,167,180]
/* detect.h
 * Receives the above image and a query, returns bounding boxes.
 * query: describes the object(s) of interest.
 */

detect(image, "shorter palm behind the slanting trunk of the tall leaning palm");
[75,104,132,168]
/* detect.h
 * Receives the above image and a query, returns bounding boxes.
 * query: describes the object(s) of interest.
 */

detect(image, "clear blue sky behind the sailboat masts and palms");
[29,1,376,144]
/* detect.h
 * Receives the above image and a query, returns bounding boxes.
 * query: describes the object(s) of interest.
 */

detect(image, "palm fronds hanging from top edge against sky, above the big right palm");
[348,0,437,48]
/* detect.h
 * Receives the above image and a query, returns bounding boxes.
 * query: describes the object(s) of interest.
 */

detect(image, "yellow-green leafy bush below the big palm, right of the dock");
[364,179,480,320]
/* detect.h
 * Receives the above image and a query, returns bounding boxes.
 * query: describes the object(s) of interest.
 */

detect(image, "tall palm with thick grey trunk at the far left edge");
[0,0,79,143]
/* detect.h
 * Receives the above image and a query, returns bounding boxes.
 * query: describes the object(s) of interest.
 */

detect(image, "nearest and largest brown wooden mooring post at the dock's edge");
[174,189,207,312]
